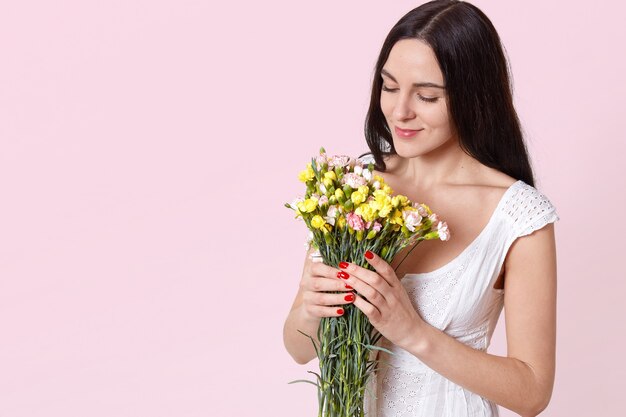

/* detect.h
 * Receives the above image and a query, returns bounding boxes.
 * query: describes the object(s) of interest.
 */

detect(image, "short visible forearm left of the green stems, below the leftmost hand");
[283,306,320,364]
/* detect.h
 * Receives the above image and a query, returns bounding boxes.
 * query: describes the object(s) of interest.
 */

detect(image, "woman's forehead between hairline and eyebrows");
[383,39,444,85]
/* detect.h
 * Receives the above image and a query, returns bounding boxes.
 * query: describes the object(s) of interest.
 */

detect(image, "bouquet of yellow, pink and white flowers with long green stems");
[285,148,450,417]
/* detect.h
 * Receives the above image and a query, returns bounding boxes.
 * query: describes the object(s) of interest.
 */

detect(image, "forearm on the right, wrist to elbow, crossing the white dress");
[403,322,549,417]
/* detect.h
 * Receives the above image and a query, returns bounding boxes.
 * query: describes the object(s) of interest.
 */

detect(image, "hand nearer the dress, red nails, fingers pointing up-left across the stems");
[337,251,425,348]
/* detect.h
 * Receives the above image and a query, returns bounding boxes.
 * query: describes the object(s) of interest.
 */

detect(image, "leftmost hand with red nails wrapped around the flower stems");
[300,250,355,320]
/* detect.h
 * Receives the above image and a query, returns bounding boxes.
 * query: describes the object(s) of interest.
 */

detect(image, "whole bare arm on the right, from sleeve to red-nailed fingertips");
[338,224,556,417]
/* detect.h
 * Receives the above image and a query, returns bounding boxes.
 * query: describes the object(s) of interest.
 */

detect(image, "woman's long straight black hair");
[365,0,535,186]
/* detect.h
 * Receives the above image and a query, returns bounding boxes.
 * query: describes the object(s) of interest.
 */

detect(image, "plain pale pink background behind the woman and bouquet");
[0,0,626,417]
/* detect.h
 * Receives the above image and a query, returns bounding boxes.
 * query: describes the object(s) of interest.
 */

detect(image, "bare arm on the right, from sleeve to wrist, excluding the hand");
[400,224,556,417]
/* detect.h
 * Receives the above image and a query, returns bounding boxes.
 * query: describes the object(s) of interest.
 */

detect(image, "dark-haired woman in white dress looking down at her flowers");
[284,0,558,417]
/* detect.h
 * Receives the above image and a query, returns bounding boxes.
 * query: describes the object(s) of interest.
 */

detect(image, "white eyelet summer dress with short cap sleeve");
[356,155,559,417]
